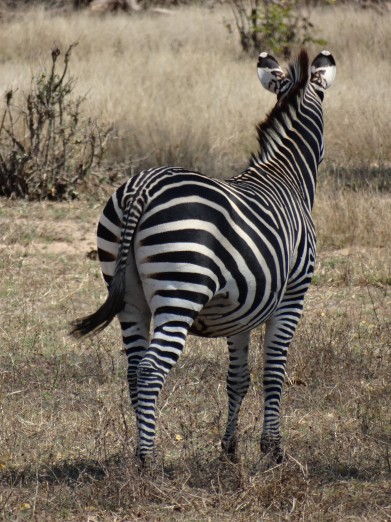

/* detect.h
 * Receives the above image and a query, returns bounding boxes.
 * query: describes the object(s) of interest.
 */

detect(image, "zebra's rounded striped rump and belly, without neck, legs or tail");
[98,168,316,337]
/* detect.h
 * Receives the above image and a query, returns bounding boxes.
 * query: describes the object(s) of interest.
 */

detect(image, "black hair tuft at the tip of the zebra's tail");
[70,269,125,339]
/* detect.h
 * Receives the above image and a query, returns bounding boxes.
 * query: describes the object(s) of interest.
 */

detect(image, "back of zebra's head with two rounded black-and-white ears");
[257,50,336,100]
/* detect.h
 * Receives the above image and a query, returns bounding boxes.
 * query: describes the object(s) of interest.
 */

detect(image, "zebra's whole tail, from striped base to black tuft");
[70,183,143,338]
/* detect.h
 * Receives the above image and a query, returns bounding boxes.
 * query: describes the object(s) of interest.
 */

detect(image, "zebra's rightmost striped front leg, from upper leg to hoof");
[261,294,304,463]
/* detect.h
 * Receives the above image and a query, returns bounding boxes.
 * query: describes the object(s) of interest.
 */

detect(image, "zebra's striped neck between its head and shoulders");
[246,80,323,209]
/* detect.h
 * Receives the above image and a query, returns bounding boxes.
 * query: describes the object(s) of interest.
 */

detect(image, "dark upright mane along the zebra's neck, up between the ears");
[251,49,309,163]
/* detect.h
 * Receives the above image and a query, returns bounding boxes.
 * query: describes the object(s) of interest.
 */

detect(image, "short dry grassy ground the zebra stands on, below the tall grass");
[0,192,391,521]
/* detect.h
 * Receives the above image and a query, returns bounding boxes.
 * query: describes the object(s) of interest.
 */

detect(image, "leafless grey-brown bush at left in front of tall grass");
[0,44,109,199]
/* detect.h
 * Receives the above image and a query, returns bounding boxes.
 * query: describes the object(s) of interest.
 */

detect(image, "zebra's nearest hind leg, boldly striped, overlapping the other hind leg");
[137,321,189,465]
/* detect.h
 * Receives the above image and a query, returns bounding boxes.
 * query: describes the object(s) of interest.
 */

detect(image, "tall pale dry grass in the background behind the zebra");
[0,7,391,177]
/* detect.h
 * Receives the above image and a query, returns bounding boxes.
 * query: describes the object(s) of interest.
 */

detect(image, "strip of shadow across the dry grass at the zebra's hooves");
[0,452,378,496]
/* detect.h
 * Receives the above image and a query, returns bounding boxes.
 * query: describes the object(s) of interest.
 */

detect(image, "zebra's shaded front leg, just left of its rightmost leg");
[222,332,250,459]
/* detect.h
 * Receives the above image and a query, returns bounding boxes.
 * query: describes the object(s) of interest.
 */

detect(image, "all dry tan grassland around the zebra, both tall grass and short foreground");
[0,4,391,522]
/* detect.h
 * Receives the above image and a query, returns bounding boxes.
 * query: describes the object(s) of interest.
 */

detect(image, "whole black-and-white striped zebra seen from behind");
[71,49,336,465]
